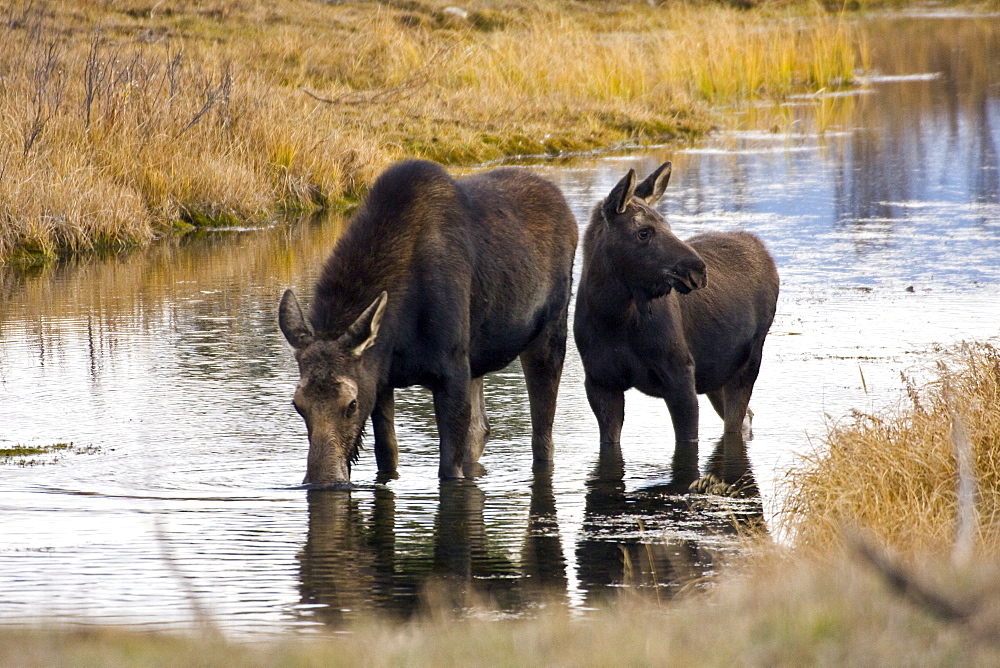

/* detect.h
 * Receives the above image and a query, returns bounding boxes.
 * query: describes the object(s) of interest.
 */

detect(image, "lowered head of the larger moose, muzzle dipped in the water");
[278,290,387,485]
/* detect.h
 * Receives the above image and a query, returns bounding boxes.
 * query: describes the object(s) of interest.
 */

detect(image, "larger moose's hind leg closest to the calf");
[521,312,566,464]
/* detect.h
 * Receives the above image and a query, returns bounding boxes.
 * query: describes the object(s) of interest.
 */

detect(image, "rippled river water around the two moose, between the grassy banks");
[0,15,1000,637]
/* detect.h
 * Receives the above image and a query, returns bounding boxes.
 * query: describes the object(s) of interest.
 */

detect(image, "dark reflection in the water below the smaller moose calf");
[576,434,765,604]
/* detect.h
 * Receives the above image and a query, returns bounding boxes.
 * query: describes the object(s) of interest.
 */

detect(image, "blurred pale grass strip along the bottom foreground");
[0,560,1000,667]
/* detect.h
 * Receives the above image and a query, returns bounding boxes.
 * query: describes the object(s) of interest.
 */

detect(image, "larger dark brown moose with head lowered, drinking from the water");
[278,160,578,485]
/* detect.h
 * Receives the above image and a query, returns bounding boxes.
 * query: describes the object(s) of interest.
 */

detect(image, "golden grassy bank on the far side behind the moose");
[0,0,865,261]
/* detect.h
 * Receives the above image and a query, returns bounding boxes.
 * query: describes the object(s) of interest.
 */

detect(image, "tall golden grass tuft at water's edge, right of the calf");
[784,344,1000,559]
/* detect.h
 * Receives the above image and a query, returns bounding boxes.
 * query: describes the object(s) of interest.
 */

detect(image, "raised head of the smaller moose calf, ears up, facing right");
[601,162,708,300]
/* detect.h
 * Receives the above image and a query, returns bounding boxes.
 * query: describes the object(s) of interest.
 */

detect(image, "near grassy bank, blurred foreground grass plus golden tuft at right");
[0,345,1000,666]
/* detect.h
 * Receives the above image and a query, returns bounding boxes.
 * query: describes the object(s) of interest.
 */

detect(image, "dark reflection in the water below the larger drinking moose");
[298,471,567,626]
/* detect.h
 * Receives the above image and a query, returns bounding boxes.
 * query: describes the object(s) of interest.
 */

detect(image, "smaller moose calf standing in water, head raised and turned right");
[573,162,779,460]
